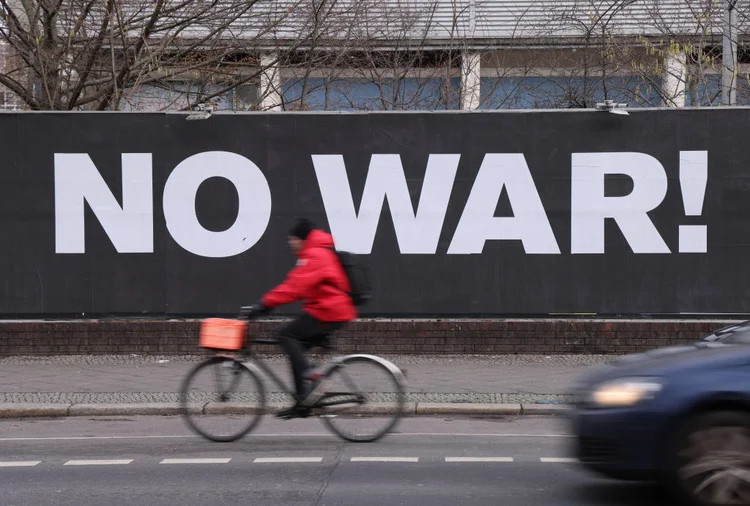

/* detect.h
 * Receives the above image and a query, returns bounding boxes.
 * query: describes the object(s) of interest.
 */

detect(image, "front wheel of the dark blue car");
[667,411,750,506]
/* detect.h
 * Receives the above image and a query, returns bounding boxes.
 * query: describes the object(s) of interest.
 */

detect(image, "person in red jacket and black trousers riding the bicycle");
[243,218,357,419]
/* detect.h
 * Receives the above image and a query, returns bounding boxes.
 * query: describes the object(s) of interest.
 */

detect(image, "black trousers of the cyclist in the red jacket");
[278,313,344,398]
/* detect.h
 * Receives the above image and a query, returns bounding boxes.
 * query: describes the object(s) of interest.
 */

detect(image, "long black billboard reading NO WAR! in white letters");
[0,108,750,316]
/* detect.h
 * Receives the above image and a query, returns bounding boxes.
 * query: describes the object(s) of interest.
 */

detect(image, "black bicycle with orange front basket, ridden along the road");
[180,313,406,442]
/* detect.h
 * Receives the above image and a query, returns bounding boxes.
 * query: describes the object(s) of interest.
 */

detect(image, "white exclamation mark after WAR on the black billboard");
[680,151,708,253]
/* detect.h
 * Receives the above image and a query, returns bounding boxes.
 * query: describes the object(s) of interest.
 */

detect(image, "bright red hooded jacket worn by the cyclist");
[261,230,357,322]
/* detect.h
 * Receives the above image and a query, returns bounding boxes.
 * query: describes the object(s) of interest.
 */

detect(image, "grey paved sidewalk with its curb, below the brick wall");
[0,355,614,418]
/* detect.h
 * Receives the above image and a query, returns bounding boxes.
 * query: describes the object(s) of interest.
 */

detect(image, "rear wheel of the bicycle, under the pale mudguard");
[315,356,406,443]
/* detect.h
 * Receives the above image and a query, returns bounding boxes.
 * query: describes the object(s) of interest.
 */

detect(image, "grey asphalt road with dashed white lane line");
[0,417,667,506]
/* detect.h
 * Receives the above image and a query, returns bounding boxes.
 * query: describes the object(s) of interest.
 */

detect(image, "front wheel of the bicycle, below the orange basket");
[180,357,265,442]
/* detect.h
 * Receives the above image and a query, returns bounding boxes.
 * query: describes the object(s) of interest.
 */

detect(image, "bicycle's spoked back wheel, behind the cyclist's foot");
[316,355,406,443]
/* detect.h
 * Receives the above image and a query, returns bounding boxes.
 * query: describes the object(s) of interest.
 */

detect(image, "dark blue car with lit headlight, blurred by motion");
[571,321,750,505]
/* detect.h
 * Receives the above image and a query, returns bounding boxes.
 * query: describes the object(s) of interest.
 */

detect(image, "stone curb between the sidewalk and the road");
[0,402,570,418]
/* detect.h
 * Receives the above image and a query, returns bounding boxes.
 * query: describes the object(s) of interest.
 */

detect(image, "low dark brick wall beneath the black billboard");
[0,319,733,356]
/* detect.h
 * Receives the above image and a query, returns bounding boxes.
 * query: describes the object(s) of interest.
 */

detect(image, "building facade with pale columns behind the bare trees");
[0,0,750,111]
